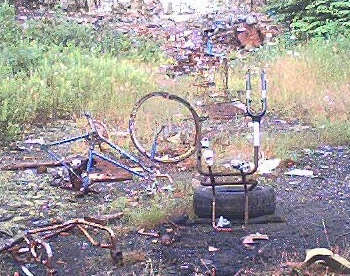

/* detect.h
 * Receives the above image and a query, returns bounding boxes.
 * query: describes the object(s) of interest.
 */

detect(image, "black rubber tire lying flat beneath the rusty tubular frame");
[193,186,276,219]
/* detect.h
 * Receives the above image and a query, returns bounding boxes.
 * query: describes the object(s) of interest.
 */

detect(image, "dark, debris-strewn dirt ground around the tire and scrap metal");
[0,115,350,276]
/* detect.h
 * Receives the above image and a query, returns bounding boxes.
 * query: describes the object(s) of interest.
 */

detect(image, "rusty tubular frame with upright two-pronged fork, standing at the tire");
[197,70,267,232]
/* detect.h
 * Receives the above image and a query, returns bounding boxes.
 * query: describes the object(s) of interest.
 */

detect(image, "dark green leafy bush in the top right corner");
[268,0,350,39]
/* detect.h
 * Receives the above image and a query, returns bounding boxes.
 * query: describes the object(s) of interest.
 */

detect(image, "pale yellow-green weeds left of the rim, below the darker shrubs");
[0,46,155,140]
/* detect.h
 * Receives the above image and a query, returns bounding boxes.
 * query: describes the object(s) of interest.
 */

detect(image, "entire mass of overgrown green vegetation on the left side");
[0,3,163,141]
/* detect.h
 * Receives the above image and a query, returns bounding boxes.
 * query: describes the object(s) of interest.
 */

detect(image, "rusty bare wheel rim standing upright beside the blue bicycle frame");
[129,92,200,163]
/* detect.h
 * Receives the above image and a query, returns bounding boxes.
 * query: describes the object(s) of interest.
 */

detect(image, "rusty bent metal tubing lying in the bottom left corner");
[0,219,123,276]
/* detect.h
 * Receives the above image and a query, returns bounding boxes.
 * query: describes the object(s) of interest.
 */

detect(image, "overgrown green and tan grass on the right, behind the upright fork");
[224,36,350,154]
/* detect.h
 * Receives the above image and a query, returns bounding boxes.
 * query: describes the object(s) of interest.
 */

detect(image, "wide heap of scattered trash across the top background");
[17,0,280,76]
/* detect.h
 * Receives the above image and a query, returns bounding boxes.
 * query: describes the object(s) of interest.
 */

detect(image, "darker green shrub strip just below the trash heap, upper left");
[24,15,161,62]
